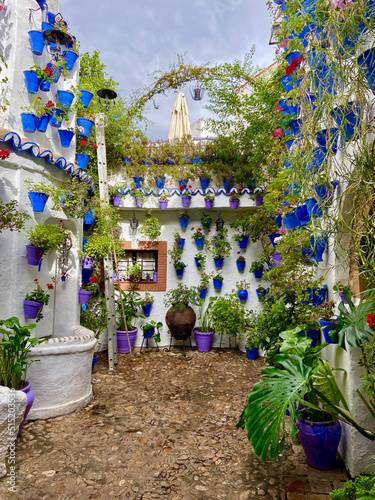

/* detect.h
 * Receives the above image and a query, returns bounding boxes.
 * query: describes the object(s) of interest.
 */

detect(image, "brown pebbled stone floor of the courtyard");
[0,348,347,500]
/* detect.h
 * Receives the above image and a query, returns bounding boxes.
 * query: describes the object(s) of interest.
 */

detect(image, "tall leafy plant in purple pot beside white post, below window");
[116,287,144,354]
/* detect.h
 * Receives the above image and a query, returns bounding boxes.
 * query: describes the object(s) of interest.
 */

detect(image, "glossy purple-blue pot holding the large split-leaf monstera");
[296,420,341,470]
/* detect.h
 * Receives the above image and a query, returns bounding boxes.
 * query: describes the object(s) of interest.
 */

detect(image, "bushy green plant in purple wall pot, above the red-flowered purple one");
[26,224,68,266]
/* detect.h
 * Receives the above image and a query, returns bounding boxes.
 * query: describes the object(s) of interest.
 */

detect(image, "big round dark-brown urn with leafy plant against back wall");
[164,283,200,340]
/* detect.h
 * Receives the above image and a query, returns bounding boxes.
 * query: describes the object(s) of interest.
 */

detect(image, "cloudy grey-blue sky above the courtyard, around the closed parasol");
[60,0,274,139]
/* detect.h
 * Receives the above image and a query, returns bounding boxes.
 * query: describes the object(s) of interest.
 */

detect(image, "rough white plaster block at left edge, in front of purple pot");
[0,386,26,478]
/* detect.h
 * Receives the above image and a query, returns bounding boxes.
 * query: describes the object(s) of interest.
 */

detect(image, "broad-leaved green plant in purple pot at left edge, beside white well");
[0,317,46,435]
